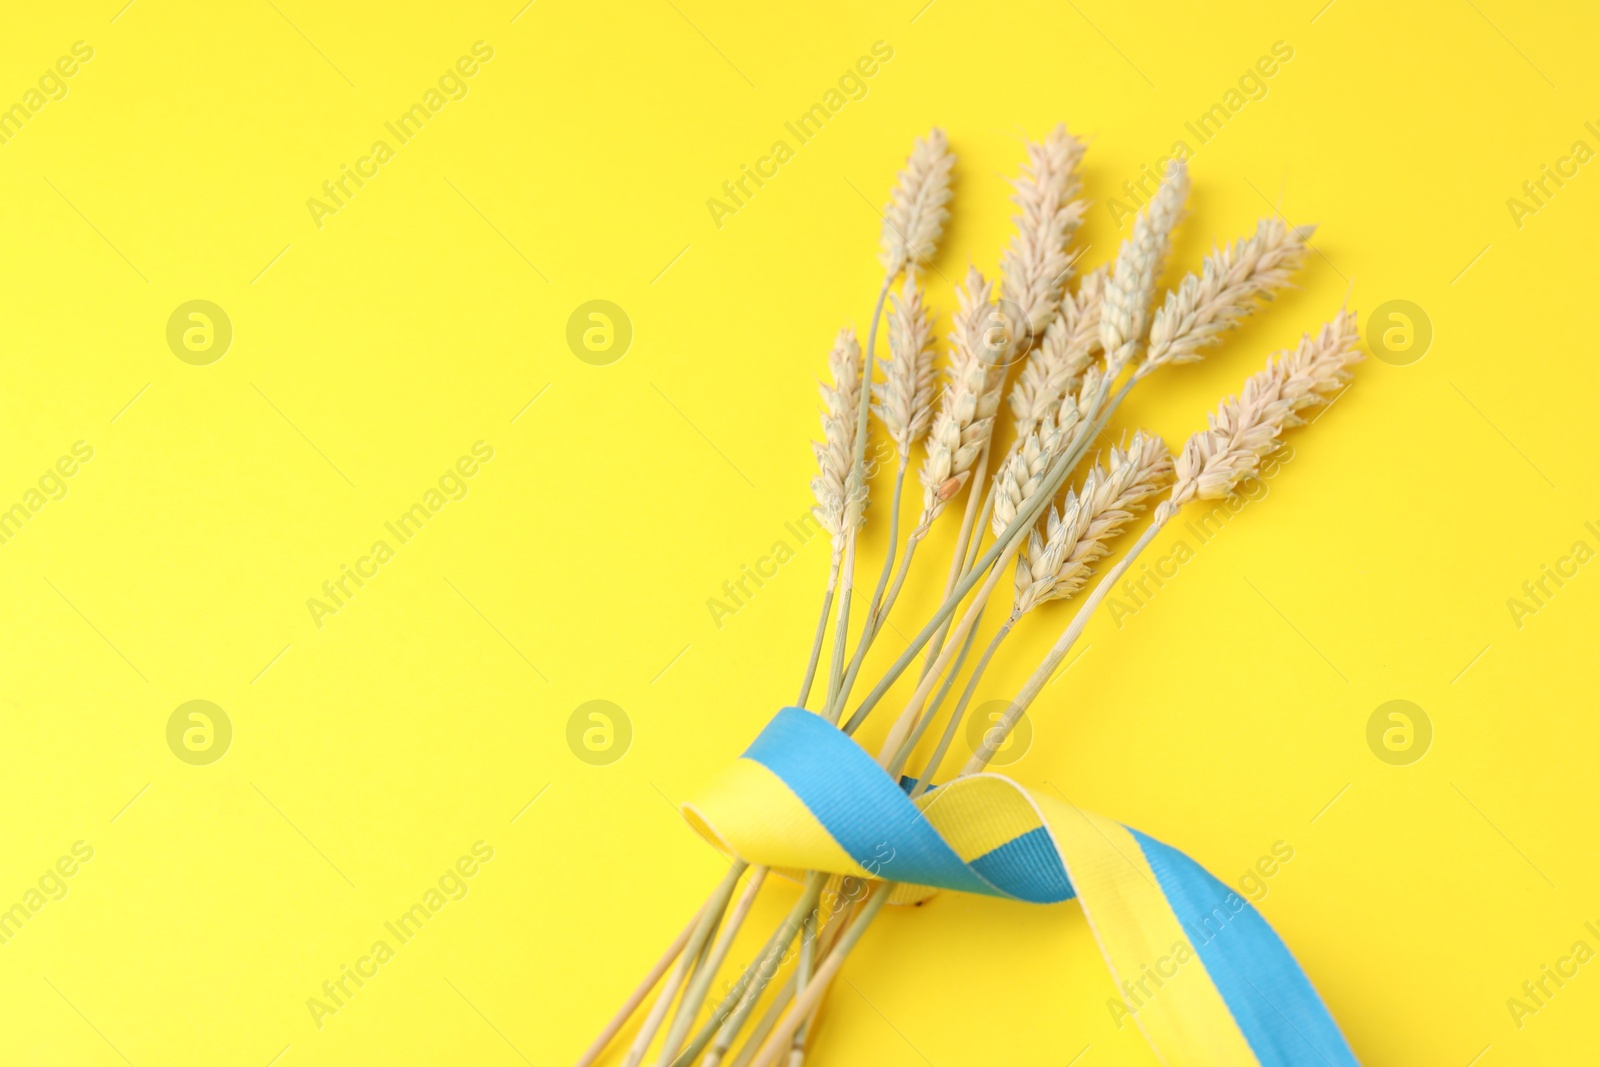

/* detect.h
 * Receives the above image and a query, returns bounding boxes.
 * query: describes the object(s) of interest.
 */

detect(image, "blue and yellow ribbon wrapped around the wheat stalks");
[683,707,1357,1067]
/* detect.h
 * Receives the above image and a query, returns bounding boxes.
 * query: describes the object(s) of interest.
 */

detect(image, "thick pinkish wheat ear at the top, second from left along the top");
[1000,125,1083,336]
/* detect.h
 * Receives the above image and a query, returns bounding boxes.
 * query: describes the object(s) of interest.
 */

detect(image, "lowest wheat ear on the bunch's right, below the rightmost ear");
[1011,430,1173,617]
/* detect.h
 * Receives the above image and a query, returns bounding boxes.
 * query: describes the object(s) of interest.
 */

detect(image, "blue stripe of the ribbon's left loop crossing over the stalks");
[744,707,1004,899]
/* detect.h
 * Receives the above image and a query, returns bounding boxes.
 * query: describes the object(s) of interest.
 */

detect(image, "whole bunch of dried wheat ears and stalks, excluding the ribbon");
[579,126,1360,1067]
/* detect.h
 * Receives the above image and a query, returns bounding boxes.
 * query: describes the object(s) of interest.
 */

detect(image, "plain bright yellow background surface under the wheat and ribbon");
[0,0,1600,1067]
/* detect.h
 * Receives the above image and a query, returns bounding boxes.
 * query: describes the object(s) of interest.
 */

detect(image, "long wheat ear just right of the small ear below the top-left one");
[918,267,1002,525]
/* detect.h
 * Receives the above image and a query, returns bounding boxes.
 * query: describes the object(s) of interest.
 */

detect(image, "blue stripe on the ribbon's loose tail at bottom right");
[1128,827,1357,1067]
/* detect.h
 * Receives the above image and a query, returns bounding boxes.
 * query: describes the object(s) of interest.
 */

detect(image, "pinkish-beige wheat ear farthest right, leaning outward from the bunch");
[1163,312,1362,509]
